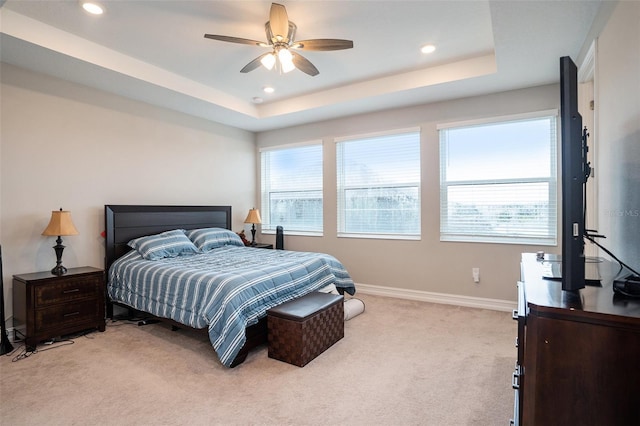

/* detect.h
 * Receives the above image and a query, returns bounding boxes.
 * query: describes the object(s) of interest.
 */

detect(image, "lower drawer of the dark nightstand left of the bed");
[34,299,99,333]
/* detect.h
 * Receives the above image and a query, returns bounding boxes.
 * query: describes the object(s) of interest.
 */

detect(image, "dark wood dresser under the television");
[512,253,640,426]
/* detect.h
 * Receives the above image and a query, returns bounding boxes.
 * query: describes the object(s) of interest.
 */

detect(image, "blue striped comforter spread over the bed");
[107,246,355,367]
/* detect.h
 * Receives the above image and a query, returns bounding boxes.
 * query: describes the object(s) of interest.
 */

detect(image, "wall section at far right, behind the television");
[595,1,640,271]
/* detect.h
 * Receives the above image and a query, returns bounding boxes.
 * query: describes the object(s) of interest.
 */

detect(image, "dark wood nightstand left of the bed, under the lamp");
[13,266,105,349]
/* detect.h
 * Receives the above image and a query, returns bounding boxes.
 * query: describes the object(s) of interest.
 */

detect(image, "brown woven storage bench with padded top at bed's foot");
[267,292,344,367]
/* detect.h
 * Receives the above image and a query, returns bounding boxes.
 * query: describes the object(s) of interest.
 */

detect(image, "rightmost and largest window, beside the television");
[438,111,557,245]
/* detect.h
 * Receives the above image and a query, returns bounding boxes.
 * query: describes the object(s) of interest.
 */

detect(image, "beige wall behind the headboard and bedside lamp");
[0,64,256,324]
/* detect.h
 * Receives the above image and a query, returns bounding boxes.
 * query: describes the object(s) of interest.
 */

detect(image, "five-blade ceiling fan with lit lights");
[204,3,353,76]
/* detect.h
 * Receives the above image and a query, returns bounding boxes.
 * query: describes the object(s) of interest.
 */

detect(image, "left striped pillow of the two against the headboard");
[127,229,201,260]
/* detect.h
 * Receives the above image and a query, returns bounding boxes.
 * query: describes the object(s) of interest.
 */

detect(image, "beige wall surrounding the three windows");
[257,85,560,301]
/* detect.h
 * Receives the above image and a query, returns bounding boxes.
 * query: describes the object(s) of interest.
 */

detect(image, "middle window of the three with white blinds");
[336,129,420,239]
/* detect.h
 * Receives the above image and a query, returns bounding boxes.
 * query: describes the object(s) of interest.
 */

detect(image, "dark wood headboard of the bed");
[104,205,231,271]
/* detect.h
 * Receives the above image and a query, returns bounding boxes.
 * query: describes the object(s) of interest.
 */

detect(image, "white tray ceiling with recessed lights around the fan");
[0,0,603,131]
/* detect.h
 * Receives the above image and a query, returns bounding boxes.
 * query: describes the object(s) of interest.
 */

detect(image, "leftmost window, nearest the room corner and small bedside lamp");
[260,142,322,235]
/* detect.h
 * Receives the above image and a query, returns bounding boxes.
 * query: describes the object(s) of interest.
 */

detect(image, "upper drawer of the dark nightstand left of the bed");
[34,277,102,308]
